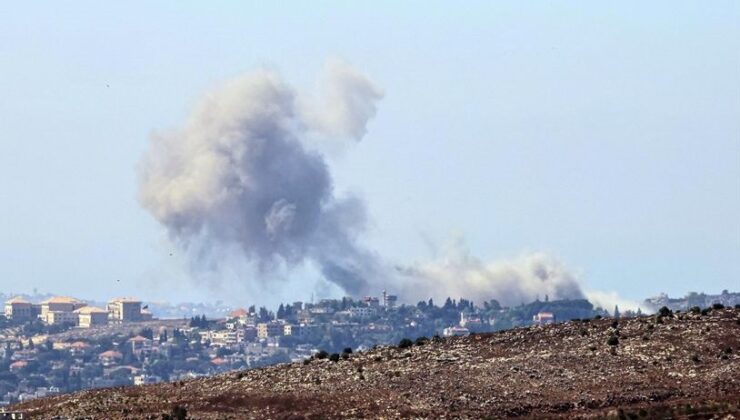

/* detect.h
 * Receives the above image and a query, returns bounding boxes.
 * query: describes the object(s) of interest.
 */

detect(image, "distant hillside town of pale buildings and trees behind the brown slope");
[0,291,740,405]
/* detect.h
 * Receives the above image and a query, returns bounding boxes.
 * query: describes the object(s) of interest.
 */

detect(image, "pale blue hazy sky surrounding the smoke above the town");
[0,1,740,306]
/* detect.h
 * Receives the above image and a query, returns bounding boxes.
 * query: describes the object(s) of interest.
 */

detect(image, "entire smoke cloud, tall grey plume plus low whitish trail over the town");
[139,62,596,304]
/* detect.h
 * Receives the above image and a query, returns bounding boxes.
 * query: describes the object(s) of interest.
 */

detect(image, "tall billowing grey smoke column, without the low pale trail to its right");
[139,62,382,294]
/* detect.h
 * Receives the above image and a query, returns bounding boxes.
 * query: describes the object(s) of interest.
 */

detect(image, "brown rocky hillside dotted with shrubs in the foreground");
[13,309,740,419]
